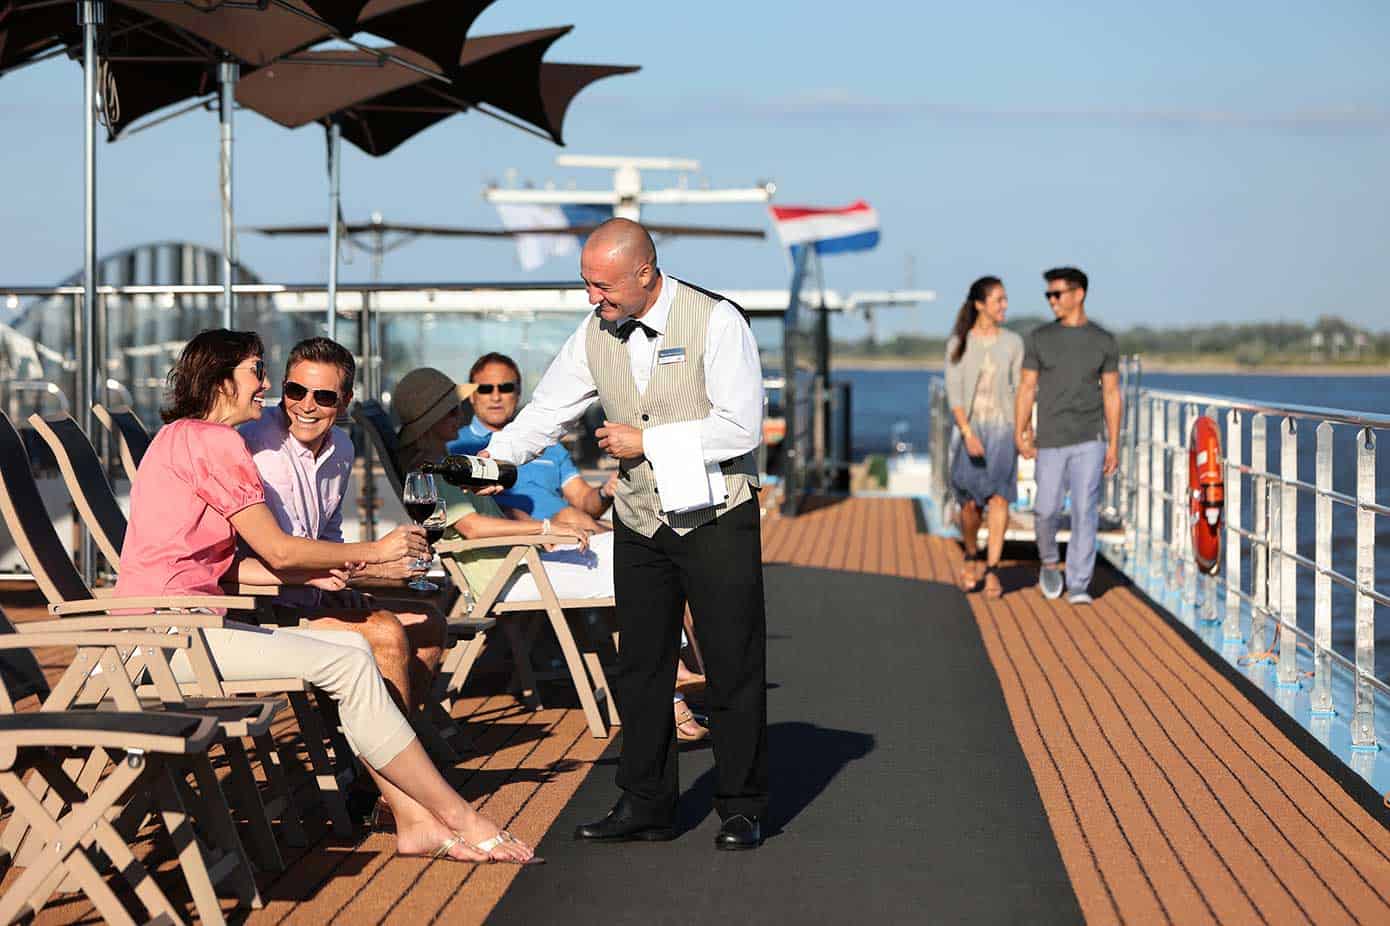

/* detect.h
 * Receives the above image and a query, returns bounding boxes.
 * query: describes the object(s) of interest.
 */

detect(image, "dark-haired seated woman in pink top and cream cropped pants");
[117,330,537,863]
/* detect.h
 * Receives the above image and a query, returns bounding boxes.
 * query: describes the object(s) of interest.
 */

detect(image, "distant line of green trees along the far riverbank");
[835,316,1390,366]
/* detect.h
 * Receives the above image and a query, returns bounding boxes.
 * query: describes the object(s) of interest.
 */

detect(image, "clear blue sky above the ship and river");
[0,0,1390,335]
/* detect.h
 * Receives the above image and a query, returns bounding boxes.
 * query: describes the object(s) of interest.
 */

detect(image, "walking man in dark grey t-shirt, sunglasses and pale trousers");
[1013,267,1122,605]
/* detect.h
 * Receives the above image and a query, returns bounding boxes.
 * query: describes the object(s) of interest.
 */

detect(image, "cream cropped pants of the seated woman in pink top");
[172,622,416,769]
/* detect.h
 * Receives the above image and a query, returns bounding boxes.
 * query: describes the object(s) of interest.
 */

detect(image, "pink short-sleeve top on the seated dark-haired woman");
[115,419,265,598]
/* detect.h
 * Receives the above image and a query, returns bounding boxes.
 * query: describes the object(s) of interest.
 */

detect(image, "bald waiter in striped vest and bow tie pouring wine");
[488,218,767,850]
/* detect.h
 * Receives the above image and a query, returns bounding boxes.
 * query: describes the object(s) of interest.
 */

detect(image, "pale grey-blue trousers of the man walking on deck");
[1033,441,1105,594]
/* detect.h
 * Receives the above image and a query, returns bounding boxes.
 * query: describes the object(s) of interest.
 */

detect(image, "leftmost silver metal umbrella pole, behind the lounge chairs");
[72,0,106,587]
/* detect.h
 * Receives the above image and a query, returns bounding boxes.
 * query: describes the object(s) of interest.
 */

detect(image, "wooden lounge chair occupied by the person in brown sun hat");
[353,402,619,738]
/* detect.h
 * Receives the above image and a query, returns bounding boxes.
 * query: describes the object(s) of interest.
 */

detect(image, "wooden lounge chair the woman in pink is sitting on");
[0,413,354,839]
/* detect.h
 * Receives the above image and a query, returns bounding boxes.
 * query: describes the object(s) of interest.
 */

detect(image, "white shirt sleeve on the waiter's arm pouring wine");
[488,314,599,466]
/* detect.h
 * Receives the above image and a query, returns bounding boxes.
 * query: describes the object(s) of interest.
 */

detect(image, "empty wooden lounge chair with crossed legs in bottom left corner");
[0,622,261,923]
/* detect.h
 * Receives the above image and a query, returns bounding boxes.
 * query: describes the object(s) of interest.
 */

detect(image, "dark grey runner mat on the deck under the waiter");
[488,566,1081,926]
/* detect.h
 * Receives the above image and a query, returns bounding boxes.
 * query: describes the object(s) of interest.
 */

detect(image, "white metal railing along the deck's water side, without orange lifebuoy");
[929,357,1390,783]
